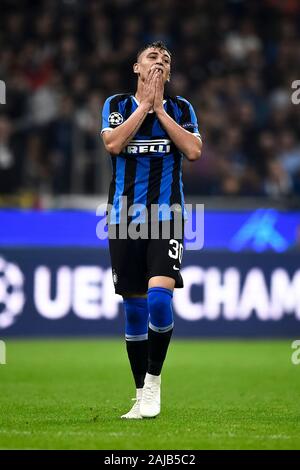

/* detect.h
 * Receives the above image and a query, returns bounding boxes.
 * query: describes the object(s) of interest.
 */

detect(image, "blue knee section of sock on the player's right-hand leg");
[148,287,173,332]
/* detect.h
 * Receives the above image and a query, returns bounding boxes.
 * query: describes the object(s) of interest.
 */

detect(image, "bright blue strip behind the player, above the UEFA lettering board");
[0,209,300,252]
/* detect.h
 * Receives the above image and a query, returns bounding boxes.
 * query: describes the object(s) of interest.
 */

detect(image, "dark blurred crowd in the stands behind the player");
[0,0,300,204]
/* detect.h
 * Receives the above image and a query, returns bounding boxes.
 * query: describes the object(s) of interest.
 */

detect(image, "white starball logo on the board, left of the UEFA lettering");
[0,257,25,329]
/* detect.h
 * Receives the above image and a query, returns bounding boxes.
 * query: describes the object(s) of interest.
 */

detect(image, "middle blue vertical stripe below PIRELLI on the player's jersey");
[132,157,151,223]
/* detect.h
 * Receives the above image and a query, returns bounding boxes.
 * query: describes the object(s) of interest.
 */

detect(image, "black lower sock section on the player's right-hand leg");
[148,328,173,375]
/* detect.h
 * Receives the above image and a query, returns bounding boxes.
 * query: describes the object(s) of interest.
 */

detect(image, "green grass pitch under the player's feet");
[0,339,300,450]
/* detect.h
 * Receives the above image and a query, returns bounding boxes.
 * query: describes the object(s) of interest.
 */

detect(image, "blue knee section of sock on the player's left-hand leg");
[124,297,149,340]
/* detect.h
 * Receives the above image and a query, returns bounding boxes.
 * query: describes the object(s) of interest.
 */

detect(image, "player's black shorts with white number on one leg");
[109,220,184,295]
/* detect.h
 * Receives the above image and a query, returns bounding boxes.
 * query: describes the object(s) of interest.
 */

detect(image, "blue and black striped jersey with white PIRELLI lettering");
[101,94,200,224]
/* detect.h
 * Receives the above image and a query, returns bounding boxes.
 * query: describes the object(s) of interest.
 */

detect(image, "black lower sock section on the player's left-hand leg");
[126,339,148,388]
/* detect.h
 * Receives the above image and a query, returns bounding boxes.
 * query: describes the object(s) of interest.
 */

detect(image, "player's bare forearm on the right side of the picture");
[156,109,202,161]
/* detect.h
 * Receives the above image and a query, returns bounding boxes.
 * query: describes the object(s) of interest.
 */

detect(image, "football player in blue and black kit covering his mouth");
[101,41,202,419]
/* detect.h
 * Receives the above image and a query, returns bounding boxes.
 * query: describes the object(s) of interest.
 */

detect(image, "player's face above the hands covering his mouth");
[134,47,171,82]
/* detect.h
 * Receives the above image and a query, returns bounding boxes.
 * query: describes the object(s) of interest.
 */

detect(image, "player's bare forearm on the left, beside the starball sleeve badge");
[103,103,150,155]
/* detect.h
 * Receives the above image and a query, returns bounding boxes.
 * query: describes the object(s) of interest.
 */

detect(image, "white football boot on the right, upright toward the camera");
[140,373,161,418]
